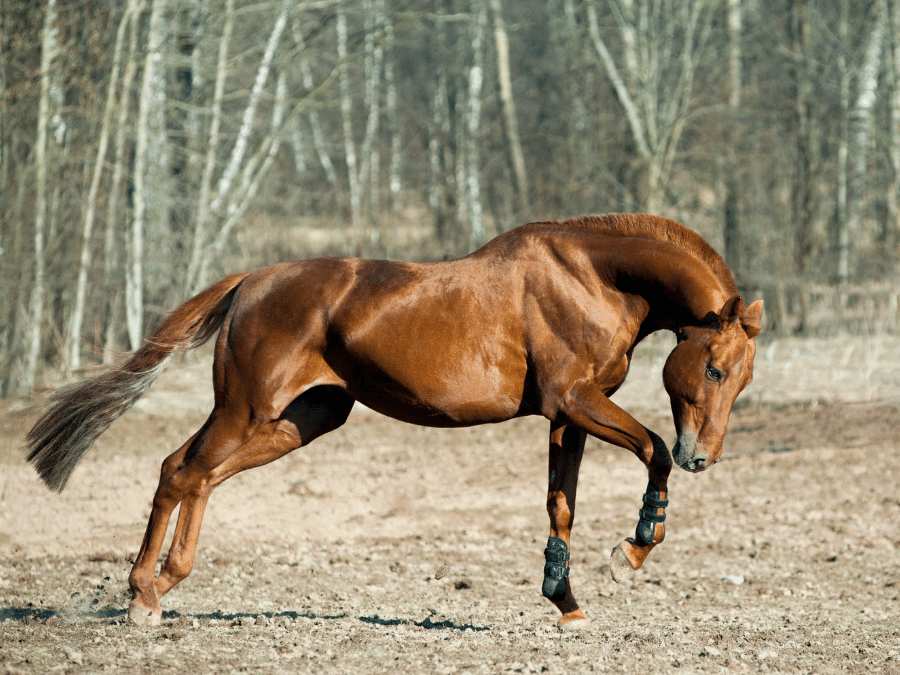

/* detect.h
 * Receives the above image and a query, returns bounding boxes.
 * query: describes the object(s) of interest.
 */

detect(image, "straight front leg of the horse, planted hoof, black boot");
[541,422,588,628]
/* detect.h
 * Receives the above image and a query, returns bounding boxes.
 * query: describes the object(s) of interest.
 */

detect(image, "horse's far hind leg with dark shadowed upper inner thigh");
[129,387,354,624]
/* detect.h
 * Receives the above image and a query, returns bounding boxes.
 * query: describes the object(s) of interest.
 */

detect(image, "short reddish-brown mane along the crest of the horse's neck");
[558,213,738,295]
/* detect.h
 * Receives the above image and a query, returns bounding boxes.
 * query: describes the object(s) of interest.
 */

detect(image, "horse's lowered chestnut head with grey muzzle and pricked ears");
[663,295,763,471]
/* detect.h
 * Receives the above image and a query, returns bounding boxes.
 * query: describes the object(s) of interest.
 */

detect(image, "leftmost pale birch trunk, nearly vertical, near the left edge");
[22,0,59,391]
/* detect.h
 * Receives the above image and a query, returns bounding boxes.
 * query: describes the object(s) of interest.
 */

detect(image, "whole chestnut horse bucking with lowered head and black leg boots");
[27,215,762,627]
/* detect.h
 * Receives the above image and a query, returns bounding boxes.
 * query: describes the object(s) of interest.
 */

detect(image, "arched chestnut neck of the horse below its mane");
[593,237,737,332]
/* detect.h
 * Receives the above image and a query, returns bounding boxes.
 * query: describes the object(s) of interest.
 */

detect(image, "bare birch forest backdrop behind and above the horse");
[0,0,900,396]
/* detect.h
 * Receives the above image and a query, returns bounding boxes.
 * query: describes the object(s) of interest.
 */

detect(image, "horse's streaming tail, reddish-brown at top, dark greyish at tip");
[25,274,247,492]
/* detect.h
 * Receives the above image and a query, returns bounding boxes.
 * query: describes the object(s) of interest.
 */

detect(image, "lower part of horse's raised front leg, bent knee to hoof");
[610,429,672,582]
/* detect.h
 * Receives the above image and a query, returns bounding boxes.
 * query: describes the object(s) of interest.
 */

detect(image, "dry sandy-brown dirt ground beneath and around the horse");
[0,338,900,675]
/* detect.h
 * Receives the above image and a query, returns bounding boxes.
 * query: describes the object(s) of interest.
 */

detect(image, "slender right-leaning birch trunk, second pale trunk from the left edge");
[65,0,137,369]
